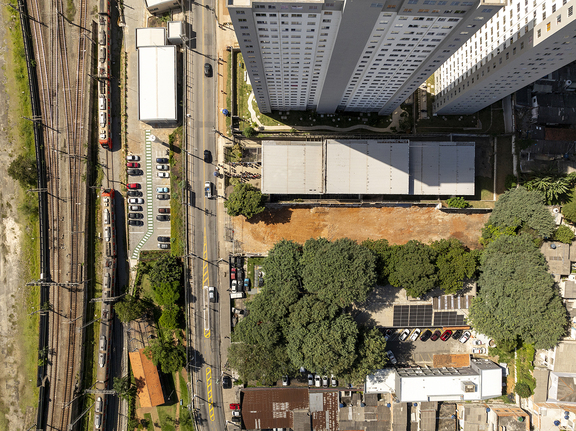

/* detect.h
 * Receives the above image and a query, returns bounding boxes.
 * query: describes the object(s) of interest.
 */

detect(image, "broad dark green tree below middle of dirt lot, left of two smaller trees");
[302,238,376,307]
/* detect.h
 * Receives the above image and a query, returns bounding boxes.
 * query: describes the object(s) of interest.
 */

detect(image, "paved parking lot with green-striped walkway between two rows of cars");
[127,130,171,259]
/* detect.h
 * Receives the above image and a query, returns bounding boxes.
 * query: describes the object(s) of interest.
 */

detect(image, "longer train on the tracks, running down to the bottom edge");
[94,189,117,430]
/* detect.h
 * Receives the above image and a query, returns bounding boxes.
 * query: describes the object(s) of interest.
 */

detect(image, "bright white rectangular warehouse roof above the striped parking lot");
[138,45,178,122]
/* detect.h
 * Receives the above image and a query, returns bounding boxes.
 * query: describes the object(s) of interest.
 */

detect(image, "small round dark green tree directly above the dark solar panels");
[389,240,438,298]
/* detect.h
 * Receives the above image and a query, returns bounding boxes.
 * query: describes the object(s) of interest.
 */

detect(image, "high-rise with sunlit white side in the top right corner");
[434,0,576,114]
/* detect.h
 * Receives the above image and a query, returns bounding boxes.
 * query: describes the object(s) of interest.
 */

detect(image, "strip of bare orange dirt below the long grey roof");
[232,207,489,253]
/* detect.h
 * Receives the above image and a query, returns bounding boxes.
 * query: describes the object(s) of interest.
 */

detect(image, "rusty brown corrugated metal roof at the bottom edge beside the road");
[242,388,309,429]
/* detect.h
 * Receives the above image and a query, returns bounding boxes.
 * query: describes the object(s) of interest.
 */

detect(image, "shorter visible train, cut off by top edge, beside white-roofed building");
[97,0,112,150]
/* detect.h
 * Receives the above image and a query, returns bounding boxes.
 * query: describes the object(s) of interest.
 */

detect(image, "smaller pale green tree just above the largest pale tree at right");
[487,187,556,238]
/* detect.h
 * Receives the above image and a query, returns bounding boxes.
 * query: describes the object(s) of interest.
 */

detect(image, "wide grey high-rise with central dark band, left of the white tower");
[228,0,507,115]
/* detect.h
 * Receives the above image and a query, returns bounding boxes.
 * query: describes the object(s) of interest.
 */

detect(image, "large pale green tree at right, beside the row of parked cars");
[469,234,568,349]
